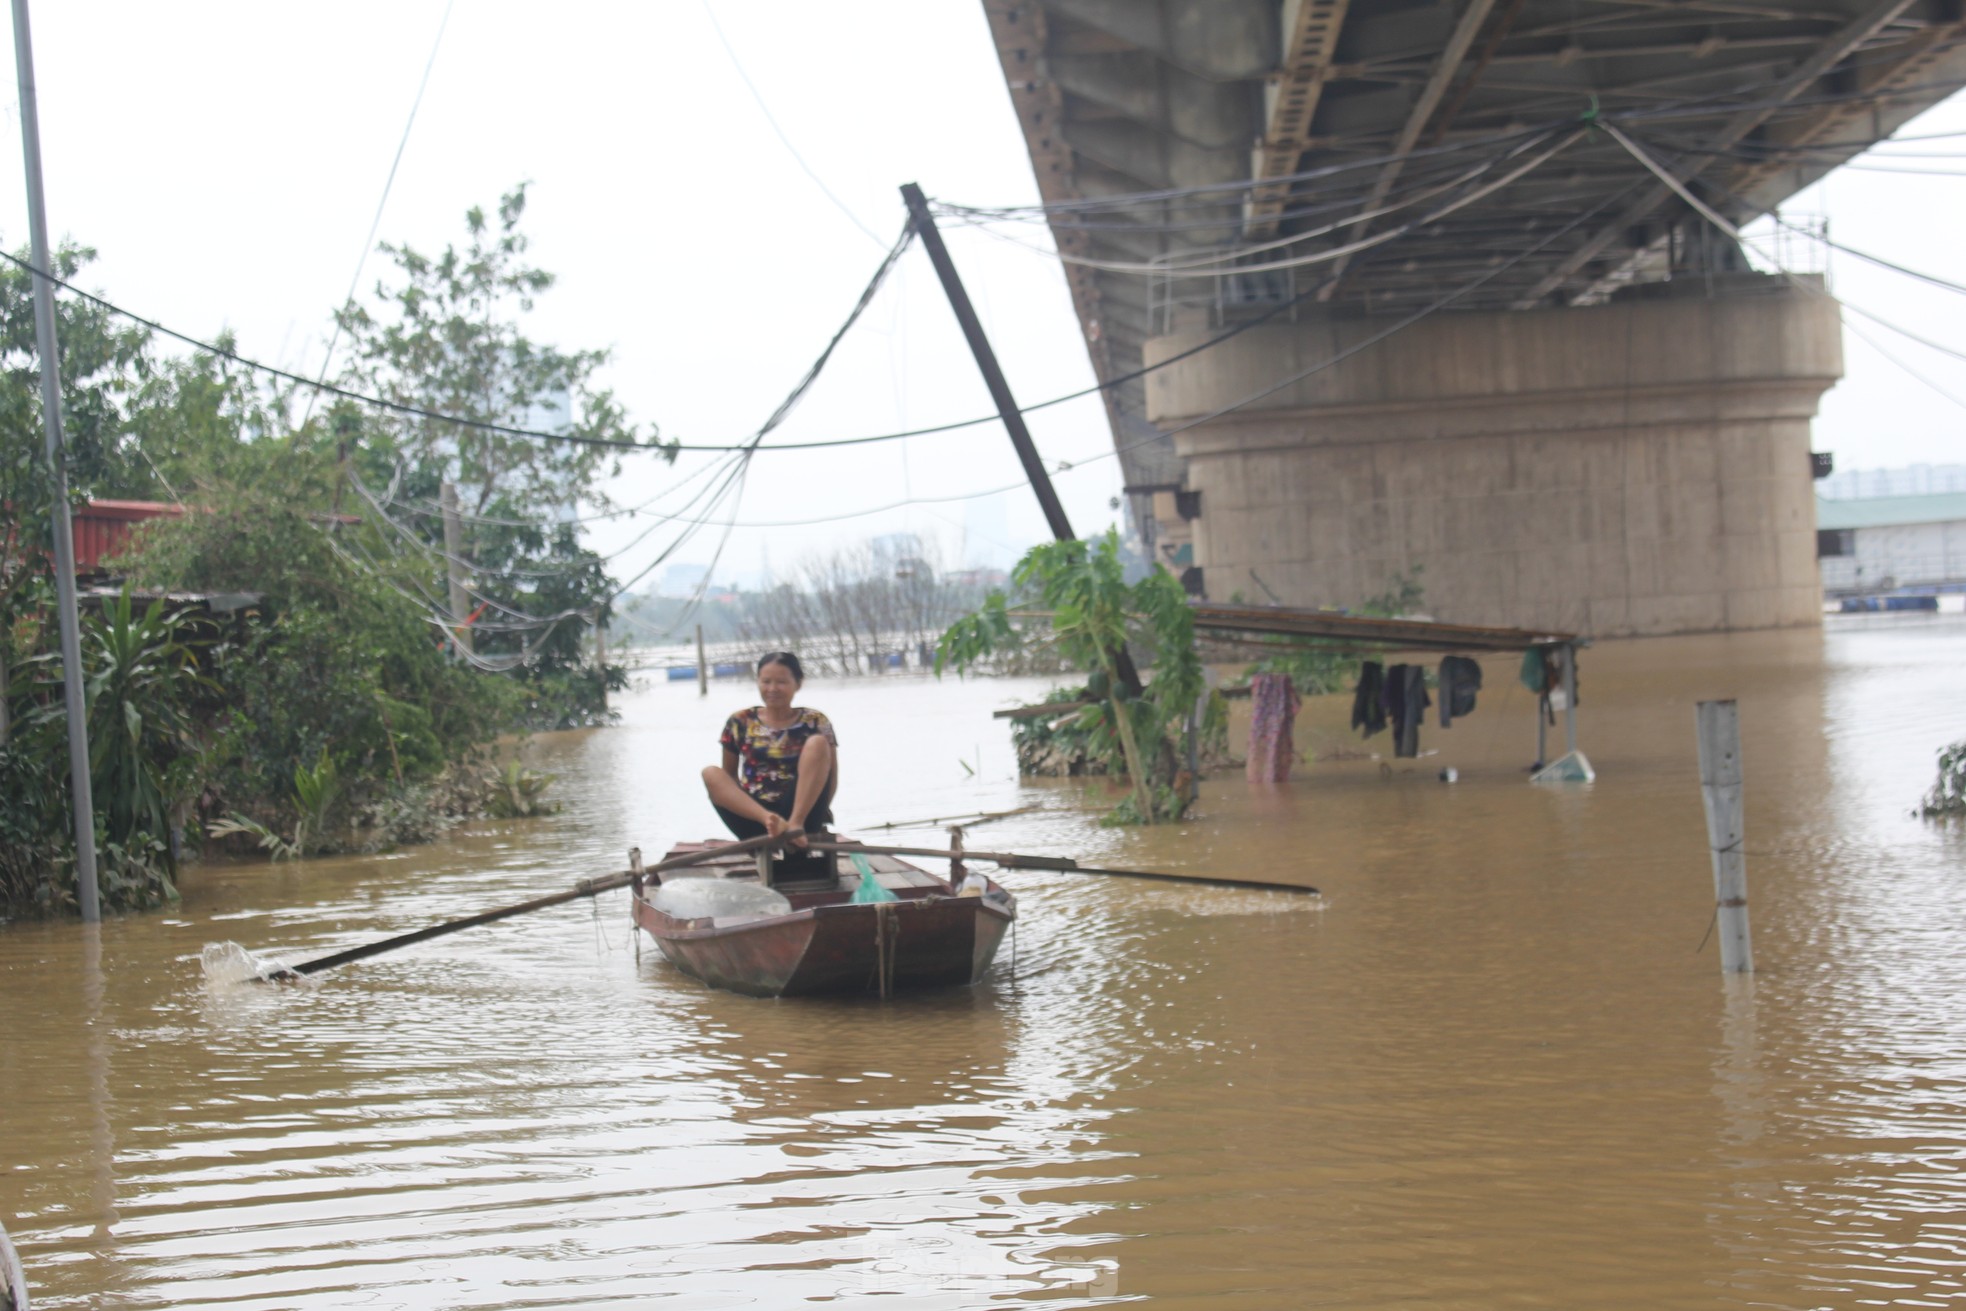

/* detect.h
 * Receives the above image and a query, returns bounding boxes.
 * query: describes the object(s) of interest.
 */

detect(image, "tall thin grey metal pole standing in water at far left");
[14,0,102,920]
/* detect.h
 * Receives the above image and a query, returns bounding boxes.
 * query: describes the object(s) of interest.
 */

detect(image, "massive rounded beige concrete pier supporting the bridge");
[1144,273,1842,637]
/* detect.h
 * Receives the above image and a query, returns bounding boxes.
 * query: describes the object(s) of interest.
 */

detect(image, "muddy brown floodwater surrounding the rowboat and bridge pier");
[0,621,1966,1309]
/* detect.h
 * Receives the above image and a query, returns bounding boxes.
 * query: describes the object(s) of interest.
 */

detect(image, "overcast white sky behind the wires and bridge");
[0,0,1966,593]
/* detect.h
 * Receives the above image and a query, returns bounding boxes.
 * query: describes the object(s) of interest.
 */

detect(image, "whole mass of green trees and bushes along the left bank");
[0,189,672,914]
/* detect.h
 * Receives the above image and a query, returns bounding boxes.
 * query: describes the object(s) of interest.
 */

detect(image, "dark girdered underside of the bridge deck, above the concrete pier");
[983,0,1966,513]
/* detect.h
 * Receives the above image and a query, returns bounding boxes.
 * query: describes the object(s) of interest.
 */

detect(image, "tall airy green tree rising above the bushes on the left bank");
[336,185,676,725]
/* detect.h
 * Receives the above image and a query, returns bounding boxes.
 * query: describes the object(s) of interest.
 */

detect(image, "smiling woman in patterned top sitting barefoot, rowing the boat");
[704,651,839,847]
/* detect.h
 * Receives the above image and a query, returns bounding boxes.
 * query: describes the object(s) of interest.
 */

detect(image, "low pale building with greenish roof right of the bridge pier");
[1817,491,1966,596]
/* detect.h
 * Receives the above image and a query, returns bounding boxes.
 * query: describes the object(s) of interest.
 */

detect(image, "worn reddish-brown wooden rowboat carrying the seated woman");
[629,841,1016,997]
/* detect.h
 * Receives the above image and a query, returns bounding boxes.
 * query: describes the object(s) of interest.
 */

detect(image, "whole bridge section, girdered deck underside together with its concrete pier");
[985,0,1966,635]
